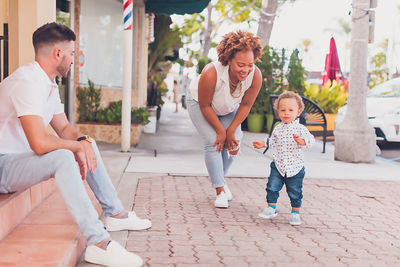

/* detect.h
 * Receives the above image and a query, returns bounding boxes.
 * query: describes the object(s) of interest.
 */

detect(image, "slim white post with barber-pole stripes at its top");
[121,0,133,152]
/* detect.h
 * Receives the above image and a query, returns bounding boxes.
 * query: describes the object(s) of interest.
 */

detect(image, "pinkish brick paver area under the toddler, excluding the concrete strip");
[127,176,400,267]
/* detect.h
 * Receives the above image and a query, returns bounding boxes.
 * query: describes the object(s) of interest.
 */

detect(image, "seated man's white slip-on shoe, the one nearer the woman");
[104,211,151,232]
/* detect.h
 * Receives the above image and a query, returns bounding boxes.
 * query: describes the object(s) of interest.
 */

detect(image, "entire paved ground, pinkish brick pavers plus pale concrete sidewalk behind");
[89,101,400,267]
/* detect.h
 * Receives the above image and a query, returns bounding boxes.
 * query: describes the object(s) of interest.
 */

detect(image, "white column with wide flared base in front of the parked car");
[334,0,376,163]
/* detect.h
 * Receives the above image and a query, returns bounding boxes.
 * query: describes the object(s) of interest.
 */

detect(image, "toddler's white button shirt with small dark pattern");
[269,119,315,177]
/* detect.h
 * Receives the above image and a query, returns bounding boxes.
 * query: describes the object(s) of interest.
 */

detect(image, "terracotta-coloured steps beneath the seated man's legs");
[0,182,101,266]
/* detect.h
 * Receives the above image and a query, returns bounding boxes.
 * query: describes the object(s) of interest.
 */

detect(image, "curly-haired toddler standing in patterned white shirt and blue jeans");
[253,92,315,225]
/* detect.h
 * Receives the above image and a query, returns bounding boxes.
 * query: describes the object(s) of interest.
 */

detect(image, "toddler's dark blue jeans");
[266,161,305,208]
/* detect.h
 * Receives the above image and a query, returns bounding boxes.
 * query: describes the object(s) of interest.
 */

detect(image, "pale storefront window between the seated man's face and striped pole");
[75,0,123,88]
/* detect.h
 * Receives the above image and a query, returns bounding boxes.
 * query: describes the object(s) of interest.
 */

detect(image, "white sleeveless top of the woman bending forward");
[189,61,255,116]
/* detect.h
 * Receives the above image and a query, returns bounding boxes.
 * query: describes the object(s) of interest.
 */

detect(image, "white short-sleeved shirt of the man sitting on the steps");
[0,62,64,154]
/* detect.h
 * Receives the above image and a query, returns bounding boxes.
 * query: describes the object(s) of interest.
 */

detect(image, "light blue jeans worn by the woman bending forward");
[186,97,243,188]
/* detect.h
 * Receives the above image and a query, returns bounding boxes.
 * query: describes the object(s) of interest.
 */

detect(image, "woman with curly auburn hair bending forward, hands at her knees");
[187,31,262,208]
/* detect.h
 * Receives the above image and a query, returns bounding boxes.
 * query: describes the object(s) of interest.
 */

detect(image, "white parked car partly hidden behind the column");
[335,77,400,142]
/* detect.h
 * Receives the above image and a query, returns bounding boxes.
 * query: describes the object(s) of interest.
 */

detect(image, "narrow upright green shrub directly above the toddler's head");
[286,49,307,95]
